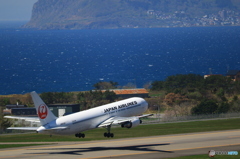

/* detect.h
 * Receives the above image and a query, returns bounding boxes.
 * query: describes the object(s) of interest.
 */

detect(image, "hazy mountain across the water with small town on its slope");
[24,0,240,29]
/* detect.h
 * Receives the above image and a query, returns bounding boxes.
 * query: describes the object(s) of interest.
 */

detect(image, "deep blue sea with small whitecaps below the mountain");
[0,22,240,95]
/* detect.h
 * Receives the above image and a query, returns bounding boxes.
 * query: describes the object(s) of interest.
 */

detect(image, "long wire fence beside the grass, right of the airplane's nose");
[143,112,240,124]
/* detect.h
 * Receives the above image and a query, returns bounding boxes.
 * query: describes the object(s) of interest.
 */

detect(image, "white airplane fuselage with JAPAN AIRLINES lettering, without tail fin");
[37,97,148,135]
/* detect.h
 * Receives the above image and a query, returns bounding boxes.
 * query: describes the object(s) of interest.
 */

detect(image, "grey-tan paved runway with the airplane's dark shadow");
[0,129,240,159]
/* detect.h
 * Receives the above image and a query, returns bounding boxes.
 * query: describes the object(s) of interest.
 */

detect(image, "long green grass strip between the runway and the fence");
[0,119,240,142]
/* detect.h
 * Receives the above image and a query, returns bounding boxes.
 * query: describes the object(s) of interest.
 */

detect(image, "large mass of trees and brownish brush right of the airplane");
[151,74,240,116]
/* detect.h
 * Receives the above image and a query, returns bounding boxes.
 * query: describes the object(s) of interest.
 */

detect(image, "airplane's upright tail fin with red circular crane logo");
[30,91,57,126]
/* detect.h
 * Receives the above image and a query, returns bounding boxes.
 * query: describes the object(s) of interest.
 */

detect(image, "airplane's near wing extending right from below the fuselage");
[98,114,153,127]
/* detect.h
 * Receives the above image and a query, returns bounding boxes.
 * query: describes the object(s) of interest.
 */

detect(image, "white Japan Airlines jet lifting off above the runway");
[5,91,153,138]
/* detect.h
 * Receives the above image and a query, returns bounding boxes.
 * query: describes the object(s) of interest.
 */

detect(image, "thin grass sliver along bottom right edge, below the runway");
[169,154,240,159]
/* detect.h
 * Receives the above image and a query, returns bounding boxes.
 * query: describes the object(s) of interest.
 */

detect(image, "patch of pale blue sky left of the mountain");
[0,0,38,21]
